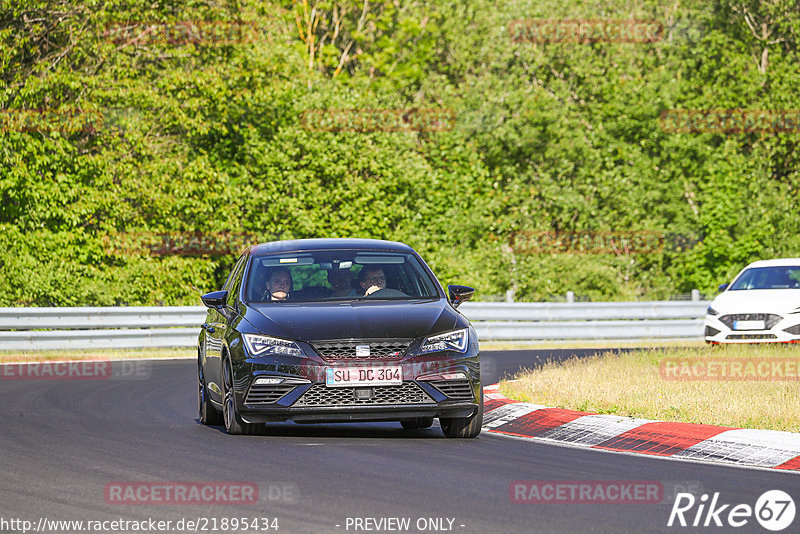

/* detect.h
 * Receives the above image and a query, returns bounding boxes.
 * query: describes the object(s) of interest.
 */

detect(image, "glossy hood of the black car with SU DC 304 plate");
[245,299,462,341]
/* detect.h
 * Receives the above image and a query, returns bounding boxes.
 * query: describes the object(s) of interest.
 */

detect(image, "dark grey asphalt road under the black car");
[0,350,800,534]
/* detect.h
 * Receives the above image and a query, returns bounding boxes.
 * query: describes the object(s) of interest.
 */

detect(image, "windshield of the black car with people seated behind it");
[245,250,439,303]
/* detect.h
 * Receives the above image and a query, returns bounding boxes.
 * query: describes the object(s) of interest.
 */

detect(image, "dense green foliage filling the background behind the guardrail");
[0,0,800,306]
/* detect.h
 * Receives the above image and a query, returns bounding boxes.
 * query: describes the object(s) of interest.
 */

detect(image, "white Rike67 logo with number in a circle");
[667,490,795,532]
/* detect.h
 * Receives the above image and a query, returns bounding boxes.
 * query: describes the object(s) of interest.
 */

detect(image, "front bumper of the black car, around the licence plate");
[228,343,481,423]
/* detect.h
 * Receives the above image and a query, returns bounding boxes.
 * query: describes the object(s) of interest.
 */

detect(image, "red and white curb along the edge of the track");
[483,384,800,472]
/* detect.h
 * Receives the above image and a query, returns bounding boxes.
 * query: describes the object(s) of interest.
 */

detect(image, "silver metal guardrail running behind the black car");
[0,301,709,350]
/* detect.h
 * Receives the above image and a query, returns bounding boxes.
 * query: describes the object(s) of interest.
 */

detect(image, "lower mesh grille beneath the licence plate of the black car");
[293,382,435,406]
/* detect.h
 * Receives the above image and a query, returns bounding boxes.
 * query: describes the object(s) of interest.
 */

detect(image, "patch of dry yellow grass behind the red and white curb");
[500,345,800,432]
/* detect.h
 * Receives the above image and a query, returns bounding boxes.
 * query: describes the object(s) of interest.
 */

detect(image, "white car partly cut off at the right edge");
[705,258,800,343]
